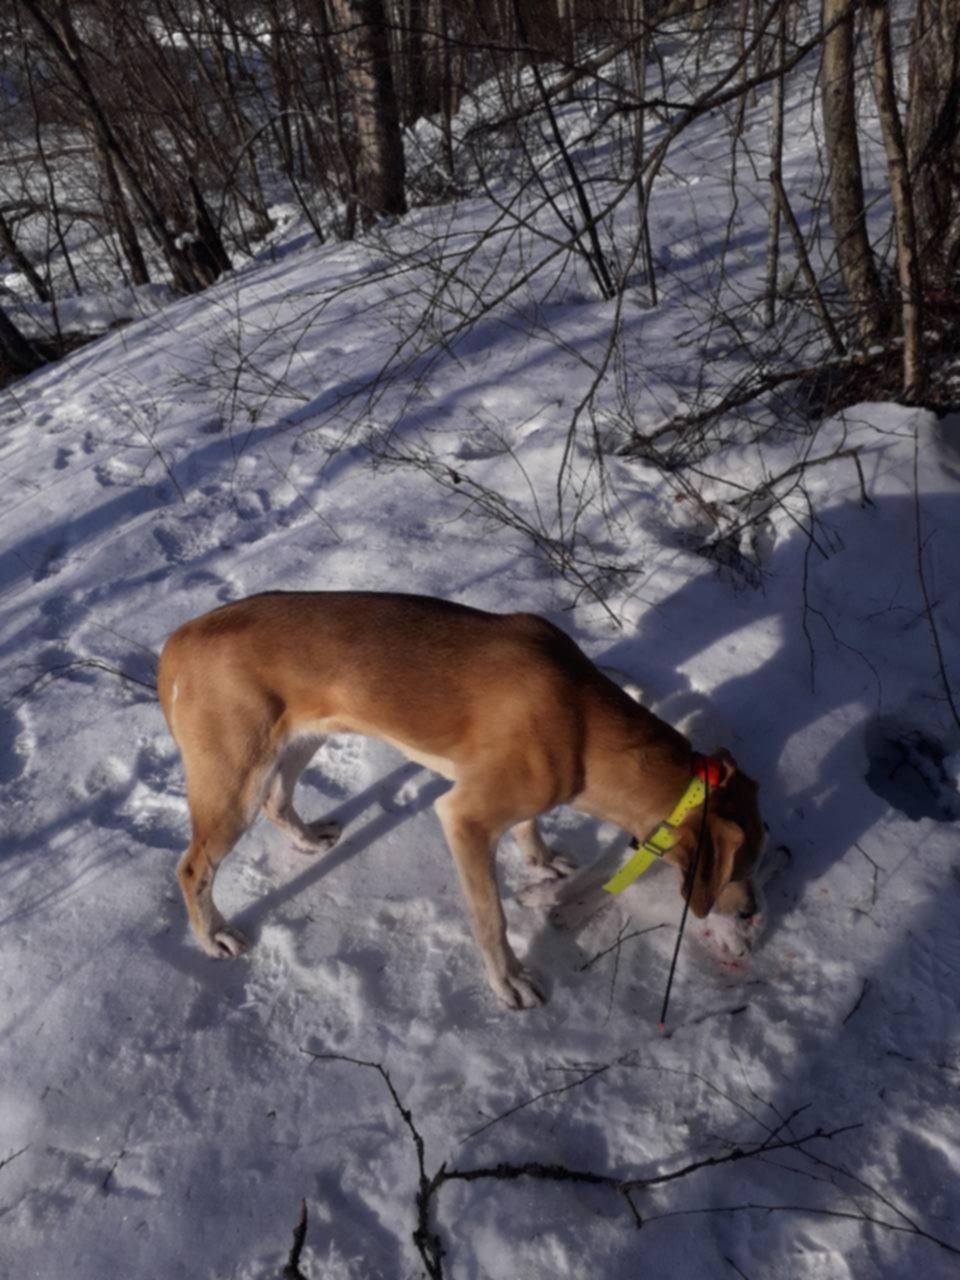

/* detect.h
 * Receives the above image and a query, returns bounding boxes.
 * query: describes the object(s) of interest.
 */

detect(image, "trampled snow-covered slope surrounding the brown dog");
[0,22,960,1280]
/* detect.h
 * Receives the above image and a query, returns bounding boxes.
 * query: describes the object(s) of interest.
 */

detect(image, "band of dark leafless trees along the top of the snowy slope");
[0,0,960,396]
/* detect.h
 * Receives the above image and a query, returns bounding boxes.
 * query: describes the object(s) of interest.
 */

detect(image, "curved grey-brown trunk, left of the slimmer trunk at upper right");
[820,0,886,343]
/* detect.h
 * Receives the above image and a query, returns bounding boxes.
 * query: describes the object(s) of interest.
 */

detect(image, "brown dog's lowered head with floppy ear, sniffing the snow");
[667,751,765,920]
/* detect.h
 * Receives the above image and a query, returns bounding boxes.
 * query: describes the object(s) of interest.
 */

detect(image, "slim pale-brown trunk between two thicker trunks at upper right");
[868,0,925,398]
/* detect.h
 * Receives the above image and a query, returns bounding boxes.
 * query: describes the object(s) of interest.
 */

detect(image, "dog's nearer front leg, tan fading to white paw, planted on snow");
[435,787,545,1009]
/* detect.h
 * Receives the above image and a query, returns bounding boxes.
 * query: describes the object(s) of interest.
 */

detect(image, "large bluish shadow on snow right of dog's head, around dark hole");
[599,483,960,892]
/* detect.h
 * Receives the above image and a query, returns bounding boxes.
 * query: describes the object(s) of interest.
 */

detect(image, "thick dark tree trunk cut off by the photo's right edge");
[906,0,960,292]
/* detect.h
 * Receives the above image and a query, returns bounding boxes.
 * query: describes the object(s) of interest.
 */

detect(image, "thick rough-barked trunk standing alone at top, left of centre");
[332,0,407,227]
